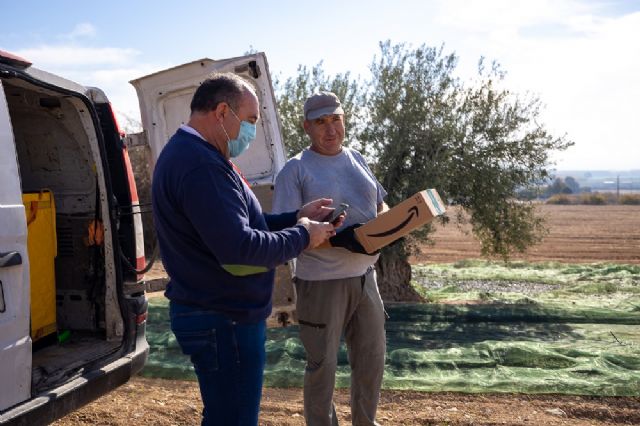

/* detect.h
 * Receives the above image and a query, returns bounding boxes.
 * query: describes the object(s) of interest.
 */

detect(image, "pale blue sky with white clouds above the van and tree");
[0,0,640,170]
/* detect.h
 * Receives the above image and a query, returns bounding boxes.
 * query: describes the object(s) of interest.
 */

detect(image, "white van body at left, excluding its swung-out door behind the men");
[0,51,149,425]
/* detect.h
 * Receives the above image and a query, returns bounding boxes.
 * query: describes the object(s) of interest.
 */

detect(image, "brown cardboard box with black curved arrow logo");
[355,189,445,253]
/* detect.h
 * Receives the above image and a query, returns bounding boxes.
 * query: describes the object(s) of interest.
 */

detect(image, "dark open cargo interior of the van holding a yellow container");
[3,78,123,394]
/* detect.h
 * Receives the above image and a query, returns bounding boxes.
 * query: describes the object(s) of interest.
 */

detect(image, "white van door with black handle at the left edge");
[0,82,31,412]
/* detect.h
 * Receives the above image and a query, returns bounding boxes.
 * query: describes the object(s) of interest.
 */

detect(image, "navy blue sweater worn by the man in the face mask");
[152,130,309,322]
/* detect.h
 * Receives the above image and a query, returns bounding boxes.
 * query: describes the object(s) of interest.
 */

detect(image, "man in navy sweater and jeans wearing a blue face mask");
[152,74,335,425]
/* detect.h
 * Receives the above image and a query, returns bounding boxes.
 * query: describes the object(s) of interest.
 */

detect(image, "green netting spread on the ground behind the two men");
[143,266,640,396]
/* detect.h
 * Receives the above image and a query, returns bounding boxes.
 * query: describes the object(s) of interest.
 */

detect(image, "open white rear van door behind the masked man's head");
[129,53,295,326]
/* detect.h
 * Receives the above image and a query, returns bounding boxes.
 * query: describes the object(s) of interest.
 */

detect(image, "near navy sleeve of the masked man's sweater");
[181,164,309,268]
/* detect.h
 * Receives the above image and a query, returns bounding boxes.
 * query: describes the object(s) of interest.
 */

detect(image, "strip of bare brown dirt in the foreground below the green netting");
[54,377,640,426]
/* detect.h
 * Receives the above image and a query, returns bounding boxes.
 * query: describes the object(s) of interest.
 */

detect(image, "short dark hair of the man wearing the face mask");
[191,73,255,114]
